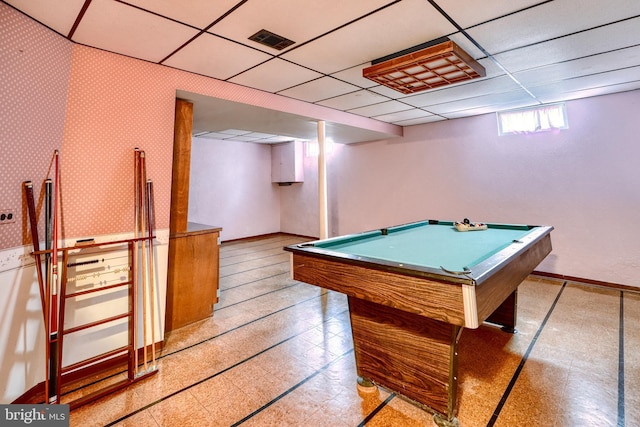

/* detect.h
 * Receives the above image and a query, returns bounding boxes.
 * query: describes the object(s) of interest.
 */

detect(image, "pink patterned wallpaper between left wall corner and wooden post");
[61,45,175,241]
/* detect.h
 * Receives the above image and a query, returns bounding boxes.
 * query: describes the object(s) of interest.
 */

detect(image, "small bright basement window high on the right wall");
[497,103,569,136]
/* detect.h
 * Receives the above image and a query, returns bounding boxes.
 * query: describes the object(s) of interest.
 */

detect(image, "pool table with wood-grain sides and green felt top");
[284,220,553,425]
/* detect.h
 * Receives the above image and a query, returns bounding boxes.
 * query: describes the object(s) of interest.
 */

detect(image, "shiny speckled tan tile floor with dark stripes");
[71,235,640,427]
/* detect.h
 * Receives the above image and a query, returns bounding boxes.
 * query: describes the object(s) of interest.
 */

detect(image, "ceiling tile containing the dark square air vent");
[209,0,388,54]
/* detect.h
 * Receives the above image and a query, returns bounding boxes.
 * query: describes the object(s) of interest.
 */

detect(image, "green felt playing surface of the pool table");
[315,222,531,271]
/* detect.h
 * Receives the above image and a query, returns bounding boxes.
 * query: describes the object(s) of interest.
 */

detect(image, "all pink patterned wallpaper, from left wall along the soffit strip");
[0,3,390,249]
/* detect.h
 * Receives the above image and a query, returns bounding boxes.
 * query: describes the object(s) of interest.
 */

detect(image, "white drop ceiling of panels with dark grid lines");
[5,0,640,142]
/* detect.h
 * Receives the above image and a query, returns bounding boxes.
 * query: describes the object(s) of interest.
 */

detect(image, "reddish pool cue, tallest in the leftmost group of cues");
[49,150,60,403]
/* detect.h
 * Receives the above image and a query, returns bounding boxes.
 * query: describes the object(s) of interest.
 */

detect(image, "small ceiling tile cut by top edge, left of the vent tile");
[127,0,238,29]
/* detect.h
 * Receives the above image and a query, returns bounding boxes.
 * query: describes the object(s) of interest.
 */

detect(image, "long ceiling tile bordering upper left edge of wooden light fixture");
[283,0,455,74]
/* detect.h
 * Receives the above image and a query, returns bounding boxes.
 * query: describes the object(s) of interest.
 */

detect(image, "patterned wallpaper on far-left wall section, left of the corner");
[0,3,72,249]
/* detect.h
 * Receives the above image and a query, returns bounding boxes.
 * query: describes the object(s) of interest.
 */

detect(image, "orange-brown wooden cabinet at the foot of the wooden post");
[165,223,222,332]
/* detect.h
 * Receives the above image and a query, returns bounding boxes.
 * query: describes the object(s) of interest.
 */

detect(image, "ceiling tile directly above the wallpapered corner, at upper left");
[73,0,198,62]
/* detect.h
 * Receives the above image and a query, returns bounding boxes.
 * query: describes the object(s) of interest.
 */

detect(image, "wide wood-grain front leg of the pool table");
[349,297,462,427]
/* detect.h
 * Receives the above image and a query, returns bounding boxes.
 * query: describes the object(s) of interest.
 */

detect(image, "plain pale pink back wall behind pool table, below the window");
[300,91,640,287]
